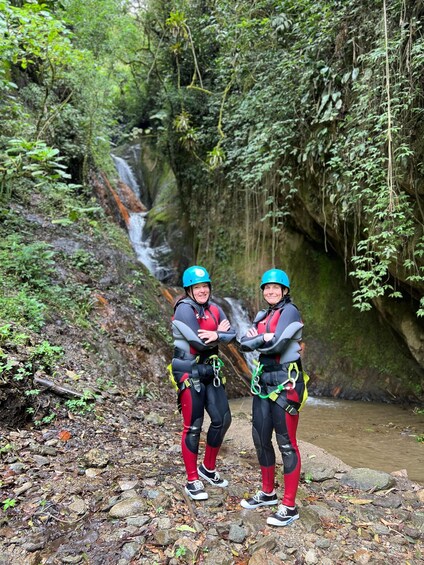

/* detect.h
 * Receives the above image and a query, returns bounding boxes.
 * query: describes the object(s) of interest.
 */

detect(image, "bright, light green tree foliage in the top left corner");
[0,0,144,188]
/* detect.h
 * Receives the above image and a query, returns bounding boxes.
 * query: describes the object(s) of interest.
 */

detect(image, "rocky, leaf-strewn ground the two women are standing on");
[0,389,424,565]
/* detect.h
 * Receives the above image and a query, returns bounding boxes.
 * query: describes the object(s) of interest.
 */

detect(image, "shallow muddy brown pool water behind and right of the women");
[230,398,424,484]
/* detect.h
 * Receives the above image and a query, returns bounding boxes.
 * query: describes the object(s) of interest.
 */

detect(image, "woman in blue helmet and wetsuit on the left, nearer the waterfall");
[171,265,235,500]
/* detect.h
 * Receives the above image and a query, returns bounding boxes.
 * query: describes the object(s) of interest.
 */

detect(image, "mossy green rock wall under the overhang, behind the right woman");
[286,234,416,386]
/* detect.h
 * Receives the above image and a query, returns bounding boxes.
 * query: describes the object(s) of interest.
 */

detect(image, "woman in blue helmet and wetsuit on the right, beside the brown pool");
[240,269,306,526]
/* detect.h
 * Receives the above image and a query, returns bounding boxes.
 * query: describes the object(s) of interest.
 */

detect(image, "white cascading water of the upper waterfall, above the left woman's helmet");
[112,155,174,281]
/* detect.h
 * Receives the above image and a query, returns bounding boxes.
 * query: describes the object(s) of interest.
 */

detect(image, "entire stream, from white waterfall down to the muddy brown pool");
[113,156,424,484]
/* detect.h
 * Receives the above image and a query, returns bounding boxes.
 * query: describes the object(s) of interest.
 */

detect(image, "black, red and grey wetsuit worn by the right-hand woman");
[241,296,305,506]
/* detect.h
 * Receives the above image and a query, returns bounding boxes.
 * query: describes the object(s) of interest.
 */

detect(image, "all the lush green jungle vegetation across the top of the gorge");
[0,0,424,324]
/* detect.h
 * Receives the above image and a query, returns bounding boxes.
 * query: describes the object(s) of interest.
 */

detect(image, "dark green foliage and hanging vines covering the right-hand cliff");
[142,0,424,316]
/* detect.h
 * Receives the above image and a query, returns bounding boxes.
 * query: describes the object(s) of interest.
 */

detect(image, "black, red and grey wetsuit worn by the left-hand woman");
[172,297,235,481]
